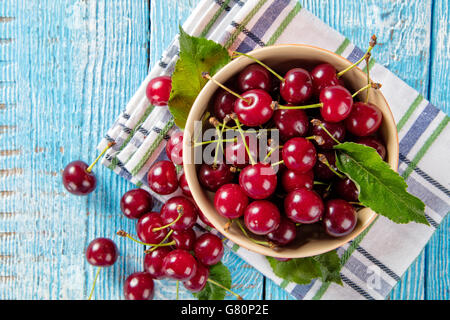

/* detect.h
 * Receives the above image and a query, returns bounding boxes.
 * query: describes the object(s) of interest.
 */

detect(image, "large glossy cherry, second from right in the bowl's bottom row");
[284,188,324,224]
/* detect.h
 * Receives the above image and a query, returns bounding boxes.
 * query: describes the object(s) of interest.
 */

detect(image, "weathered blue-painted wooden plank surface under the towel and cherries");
[0,0,450,299]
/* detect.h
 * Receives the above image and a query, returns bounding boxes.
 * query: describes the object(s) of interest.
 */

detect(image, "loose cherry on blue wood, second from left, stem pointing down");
[86,238,119,267]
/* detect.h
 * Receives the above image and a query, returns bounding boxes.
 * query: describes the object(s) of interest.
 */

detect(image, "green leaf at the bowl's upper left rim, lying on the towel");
[168,27,231,128]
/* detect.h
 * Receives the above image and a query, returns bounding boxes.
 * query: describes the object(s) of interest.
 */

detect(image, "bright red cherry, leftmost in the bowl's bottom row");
[214,183,248,219]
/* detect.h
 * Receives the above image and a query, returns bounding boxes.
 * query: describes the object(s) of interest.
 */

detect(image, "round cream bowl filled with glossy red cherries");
[183,45,399,259]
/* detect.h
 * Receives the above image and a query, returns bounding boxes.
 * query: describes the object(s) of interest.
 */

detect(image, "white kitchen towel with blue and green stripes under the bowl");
[99,0,450,299]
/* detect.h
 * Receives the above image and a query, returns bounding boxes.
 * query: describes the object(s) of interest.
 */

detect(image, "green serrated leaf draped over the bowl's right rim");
[334,142,429,225]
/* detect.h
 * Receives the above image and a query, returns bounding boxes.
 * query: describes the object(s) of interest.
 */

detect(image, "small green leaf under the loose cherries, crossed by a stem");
[192,262,231,300]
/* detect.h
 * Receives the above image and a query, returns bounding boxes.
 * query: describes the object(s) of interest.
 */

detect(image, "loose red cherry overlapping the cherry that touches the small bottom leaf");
[163,249,197,281]
